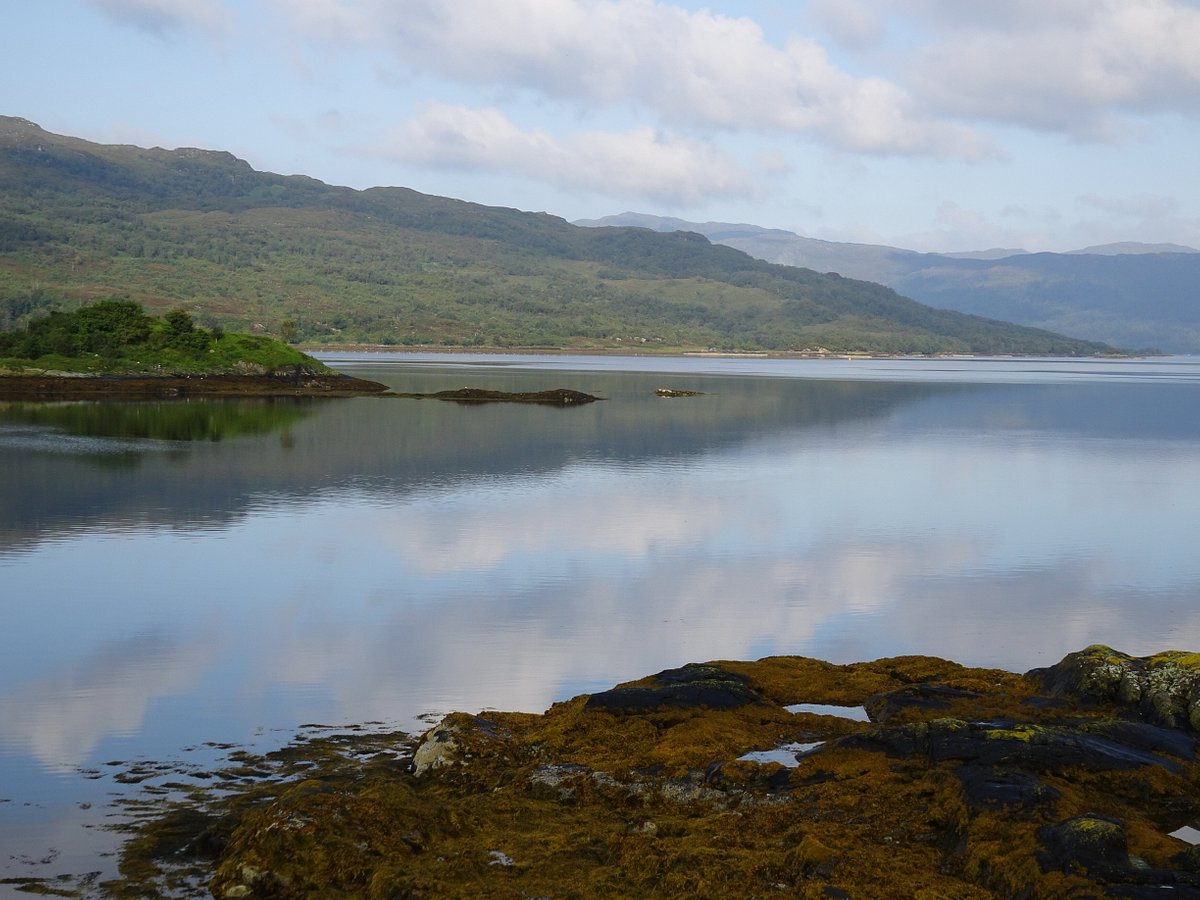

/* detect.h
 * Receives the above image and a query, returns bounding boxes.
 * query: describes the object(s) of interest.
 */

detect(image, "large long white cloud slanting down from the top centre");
[281,0,989,158]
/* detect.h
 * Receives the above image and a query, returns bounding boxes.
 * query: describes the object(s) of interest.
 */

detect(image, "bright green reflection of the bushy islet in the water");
[0,400,312,440]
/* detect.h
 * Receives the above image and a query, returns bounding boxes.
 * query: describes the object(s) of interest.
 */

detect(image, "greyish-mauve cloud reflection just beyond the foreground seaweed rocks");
[248,528,1200,734]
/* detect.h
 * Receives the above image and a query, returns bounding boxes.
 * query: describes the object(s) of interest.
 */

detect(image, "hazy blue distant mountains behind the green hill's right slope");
[576,212,1200,354]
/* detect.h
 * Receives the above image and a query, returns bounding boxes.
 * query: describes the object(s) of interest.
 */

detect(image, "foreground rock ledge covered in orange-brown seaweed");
[114,647,1200,898]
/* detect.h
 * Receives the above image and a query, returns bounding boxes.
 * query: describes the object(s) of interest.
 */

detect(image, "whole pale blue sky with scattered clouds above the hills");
[0,0,1200,252]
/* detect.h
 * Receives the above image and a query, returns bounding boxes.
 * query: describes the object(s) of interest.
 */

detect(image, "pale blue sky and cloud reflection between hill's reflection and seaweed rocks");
[0,374,1200,768]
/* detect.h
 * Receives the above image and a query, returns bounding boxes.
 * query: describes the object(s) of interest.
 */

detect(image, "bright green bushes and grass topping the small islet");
[0,299,328,374]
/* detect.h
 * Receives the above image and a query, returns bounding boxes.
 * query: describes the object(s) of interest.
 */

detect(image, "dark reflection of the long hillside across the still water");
[0,368,988,550]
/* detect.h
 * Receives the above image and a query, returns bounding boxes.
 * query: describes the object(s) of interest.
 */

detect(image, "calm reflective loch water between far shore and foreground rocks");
[0,355,1200,893]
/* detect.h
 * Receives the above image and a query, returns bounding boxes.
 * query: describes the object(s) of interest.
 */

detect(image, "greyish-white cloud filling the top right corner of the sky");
[912,0,1200,139]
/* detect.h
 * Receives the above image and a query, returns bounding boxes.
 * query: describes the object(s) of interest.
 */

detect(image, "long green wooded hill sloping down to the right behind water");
[0,118,1108,355]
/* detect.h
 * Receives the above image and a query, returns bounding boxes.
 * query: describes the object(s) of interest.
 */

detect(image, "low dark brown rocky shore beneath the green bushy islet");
[0,371,388,401]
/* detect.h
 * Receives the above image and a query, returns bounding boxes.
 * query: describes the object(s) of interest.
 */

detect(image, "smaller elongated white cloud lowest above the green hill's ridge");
[380,102,752,204]
